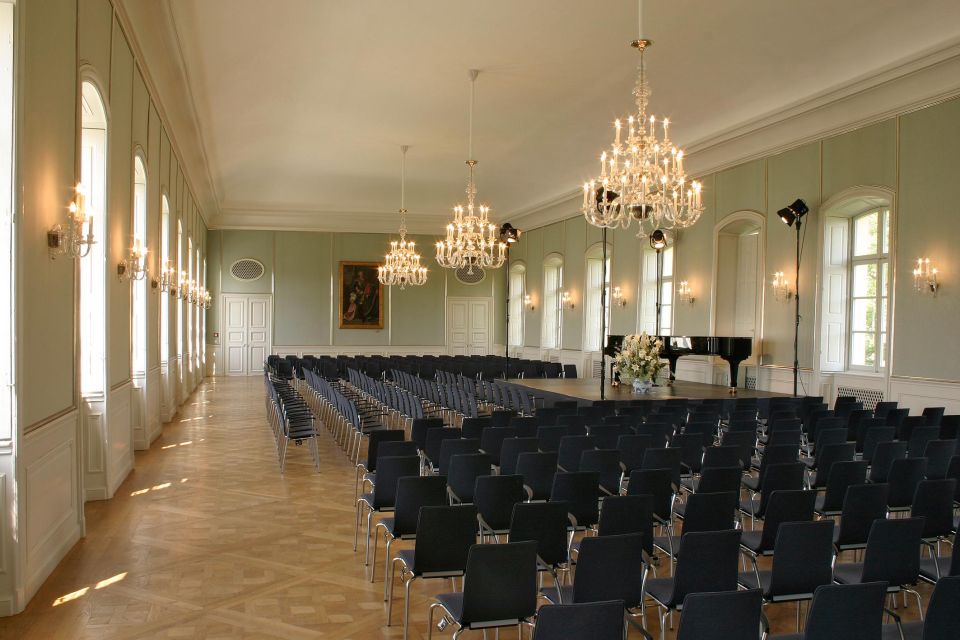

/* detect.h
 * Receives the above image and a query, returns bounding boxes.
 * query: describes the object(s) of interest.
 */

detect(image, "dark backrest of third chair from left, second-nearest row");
[671,529,740,603]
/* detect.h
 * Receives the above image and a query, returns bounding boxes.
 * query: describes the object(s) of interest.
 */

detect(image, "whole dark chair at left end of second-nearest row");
[427,541,537,639]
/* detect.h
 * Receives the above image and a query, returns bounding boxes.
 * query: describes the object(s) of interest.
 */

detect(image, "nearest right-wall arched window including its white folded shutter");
[820,190,891,372]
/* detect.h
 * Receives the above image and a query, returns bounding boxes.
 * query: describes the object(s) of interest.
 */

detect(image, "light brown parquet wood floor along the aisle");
[0,377,930,640]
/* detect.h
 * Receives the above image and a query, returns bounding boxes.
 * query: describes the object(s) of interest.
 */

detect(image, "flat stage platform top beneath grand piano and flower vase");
[507,378,788,406]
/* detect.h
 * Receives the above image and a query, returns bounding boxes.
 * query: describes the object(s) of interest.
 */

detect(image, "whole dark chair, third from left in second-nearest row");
[644,530,740,640]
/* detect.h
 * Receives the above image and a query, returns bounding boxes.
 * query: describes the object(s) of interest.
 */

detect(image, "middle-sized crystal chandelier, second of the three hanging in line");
[437,69,507,274]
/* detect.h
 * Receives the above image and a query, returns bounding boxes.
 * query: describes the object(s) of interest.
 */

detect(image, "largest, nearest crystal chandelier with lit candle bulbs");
[582,0,703,237]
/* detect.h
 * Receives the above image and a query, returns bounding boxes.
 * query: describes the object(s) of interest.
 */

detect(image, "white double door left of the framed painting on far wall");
[220,294,273,376]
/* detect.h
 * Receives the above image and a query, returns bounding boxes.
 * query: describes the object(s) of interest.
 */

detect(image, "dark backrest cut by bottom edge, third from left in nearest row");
[803,582,887,640]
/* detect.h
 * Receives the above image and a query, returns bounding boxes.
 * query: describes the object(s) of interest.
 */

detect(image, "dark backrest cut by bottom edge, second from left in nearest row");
[672,589,763,640]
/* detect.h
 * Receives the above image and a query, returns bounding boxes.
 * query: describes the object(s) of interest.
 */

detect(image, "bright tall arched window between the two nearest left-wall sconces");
[80,82,107,394]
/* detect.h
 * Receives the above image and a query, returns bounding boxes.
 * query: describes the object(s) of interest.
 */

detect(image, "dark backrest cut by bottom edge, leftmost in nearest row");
[533,600,624,640]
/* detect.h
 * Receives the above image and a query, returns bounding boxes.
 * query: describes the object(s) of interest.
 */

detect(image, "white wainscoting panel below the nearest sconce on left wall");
[21,411,82,610]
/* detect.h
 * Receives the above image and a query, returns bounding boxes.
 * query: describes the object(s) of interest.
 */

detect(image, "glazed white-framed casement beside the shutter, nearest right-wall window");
[849,209,890,371]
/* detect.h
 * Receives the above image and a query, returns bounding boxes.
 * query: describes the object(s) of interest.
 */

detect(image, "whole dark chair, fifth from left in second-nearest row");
[833,518,923,610]
